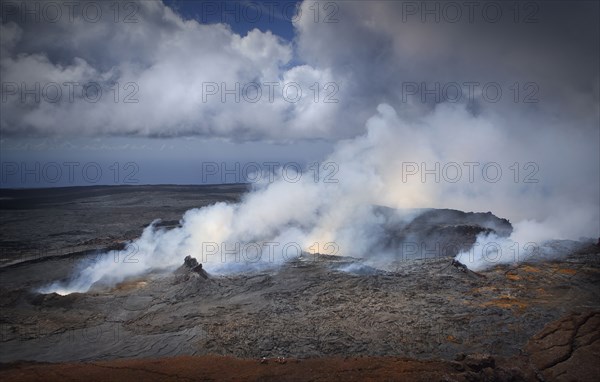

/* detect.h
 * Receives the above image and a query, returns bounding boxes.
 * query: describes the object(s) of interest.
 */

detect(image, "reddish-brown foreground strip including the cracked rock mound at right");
[0,312,600,382]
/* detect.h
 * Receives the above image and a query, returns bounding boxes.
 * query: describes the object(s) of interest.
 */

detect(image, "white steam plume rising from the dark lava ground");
[43,104,599,293]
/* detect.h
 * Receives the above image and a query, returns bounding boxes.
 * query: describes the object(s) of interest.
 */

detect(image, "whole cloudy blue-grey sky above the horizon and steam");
[0,0,600,218]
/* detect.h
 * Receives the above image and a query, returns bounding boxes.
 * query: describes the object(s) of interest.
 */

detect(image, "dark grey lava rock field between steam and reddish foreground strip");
[0,245,600,364]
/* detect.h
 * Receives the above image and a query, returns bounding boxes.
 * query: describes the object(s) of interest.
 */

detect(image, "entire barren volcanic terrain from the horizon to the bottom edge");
[0,185,600,381]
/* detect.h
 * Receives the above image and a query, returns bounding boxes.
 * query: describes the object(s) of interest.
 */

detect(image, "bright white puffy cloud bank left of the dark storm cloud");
[0,1,337,140]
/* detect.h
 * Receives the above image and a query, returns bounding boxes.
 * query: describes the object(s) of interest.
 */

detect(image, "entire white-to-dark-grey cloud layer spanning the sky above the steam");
[0,1,600,141]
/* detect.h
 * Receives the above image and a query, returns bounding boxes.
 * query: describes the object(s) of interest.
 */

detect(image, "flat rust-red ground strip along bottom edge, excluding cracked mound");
[0,356,472,381]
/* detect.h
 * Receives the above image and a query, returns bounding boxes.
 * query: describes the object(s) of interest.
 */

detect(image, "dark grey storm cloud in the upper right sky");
[297,2,599,127]
